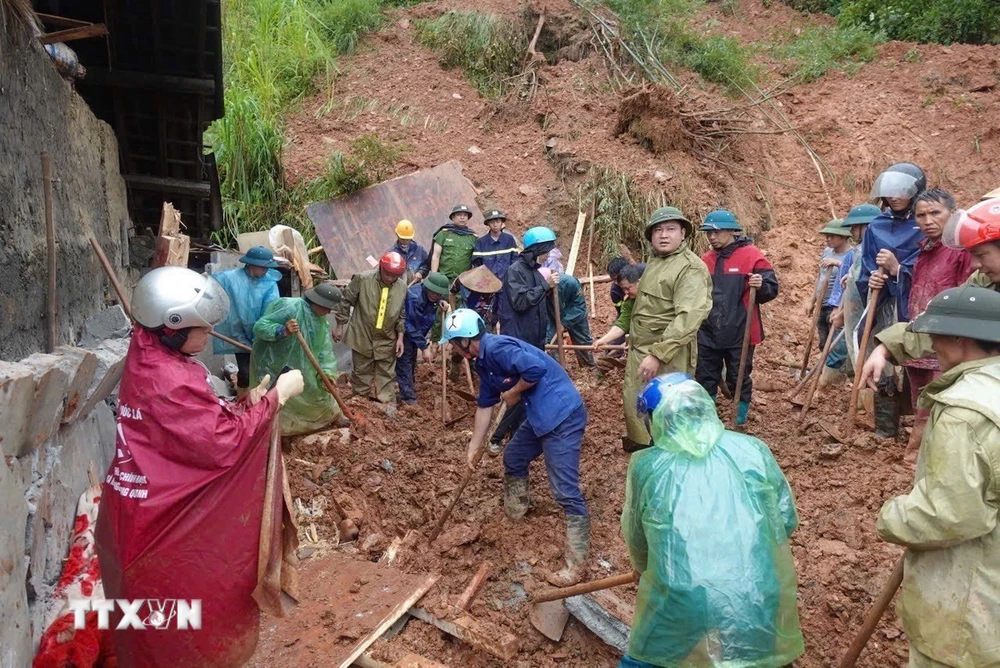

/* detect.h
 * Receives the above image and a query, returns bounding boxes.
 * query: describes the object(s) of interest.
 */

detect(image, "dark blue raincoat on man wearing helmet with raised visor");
[855,211,924,322]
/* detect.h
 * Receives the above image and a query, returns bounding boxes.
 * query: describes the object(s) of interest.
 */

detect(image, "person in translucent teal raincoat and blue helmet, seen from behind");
[618,373,804,668]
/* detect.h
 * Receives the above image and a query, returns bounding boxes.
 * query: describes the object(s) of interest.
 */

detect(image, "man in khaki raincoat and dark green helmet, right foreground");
[862,284,1000,668]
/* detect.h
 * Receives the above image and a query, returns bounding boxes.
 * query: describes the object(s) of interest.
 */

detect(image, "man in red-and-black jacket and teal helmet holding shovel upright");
[695,209,778,425]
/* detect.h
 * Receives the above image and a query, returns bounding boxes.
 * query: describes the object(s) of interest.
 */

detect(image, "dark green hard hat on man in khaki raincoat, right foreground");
[907,285,1000,343]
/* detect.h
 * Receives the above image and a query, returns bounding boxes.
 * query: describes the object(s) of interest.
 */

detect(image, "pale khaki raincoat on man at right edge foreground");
[877,357,1000,668]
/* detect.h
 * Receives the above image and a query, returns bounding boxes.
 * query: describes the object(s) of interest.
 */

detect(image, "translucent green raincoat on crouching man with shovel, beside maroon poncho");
[250,297,341,436]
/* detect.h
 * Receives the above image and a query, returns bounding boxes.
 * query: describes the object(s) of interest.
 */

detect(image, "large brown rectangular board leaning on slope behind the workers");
[306,160,483,279]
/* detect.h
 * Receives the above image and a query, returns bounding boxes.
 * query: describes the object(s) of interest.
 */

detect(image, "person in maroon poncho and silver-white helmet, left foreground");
[95,267,302,666]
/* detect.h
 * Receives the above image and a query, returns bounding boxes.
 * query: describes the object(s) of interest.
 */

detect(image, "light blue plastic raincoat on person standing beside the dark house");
[212,267,281,355]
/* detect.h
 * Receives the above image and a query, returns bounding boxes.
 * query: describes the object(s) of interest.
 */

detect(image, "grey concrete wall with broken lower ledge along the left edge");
[0,28,136,668]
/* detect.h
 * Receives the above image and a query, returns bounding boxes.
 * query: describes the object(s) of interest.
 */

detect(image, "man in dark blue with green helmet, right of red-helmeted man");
[396,271,450,404]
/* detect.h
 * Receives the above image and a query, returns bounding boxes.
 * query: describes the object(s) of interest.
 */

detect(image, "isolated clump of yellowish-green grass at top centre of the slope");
[416,11,530,98]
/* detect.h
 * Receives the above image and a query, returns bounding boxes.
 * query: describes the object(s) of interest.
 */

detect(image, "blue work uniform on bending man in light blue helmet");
[476,334,588,515]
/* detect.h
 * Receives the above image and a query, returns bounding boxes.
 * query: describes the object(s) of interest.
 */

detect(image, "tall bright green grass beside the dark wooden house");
[206,0,415,245]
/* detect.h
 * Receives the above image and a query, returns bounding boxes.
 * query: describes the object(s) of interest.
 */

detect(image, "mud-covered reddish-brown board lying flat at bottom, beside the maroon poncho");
[250,552,438,668]
